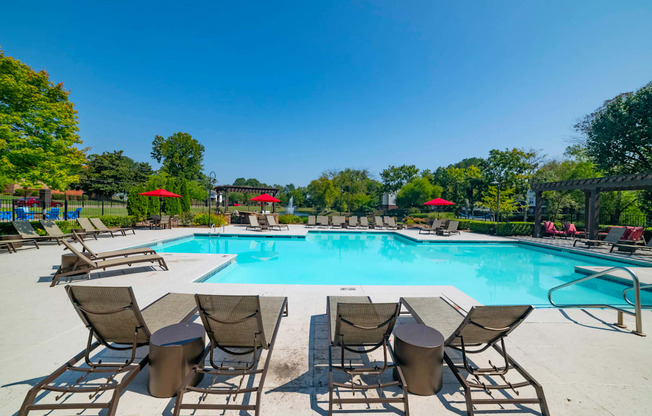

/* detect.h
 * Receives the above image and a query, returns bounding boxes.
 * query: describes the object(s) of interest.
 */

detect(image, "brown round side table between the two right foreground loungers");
[394,324,444,396]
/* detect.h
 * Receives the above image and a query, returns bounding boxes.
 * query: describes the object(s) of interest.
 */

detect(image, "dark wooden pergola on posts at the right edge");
[531,173,652,239]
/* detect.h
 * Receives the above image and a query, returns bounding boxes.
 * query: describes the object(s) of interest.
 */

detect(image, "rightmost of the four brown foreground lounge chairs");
[401,298,550,416]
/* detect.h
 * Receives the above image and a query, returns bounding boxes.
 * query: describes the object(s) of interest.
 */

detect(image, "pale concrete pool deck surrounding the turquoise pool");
[0,226,652,416]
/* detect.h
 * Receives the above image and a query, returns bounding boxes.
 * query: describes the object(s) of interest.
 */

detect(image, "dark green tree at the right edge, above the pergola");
[575,82,652,174]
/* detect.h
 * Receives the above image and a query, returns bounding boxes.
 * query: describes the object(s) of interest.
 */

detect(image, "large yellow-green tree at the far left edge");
[0,50,85,189]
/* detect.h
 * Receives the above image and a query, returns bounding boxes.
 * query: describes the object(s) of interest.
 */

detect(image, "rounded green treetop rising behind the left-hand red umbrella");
[152,132,204,180]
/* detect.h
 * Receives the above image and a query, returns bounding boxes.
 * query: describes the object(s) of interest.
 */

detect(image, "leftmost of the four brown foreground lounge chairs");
[18,286,197,416]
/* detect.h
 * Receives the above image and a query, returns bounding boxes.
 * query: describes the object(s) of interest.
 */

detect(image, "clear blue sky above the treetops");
[0,0,652,185]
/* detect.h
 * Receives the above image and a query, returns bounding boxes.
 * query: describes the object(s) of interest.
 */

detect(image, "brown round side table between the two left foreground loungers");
[148,323,206,397]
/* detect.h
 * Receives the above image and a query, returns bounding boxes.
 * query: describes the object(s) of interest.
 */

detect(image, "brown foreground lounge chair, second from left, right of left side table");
[174,295,288,416]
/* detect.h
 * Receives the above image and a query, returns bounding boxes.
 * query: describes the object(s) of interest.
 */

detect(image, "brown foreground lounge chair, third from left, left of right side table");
[326,296,410,416]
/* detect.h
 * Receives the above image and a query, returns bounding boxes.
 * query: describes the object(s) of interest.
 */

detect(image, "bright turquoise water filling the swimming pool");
[155,232,652,305]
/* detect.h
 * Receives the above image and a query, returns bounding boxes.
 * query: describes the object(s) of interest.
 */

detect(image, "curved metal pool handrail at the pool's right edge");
[548,267,652,337]
